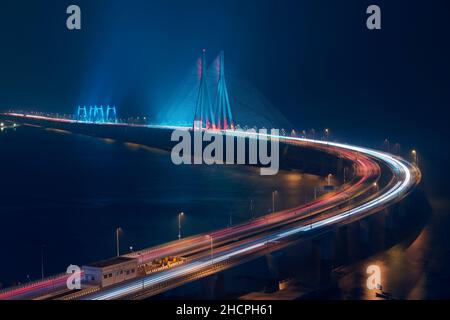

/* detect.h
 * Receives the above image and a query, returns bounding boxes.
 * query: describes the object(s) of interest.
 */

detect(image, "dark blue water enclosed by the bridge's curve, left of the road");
[0,126,324,286]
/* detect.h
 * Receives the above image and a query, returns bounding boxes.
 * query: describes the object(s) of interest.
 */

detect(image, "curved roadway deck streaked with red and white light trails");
[0,115,421,300]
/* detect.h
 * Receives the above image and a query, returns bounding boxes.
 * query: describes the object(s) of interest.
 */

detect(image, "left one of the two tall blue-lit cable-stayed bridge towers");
[193,49,216,130]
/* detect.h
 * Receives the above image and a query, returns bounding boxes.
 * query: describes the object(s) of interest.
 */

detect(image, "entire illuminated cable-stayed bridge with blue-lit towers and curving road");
[0,50,421,300]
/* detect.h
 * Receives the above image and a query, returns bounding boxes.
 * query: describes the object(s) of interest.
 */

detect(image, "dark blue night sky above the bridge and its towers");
[0,0,450,195]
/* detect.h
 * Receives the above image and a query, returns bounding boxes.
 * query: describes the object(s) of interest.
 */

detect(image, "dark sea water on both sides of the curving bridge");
[0,126,450,299]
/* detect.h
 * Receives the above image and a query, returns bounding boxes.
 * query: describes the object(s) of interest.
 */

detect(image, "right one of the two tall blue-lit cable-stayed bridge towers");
[214,51,234,130]
